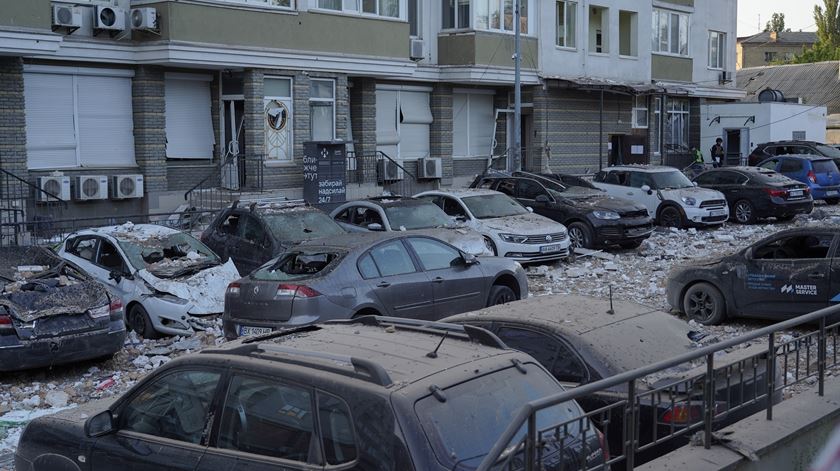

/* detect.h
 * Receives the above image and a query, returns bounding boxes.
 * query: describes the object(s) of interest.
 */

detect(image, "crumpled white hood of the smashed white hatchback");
[137,260,240,315]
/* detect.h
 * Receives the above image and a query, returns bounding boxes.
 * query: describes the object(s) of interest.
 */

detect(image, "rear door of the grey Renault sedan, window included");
[359,239,435,319]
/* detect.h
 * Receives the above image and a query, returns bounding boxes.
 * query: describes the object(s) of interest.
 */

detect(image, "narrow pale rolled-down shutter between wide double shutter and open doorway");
[166,74,216,159]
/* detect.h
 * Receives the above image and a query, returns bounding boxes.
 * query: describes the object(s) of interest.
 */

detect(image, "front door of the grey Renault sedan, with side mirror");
[405,237,482,319]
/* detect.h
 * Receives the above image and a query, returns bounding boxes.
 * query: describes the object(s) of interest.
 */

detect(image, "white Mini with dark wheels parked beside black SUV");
[593,165,729,228]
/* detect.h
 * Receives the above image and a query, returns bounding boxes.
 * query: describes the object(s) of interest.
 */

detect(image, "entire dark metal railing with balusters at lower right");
[477,306,840,471]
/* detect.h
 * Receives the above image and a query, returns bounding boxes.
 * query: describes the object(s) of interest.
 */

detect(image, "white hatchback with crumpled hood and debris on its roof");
[57,222,239,338]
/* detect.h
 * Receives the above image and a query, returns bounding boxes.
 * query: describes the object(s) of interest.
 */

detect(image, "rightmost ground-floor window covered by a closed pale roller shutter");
[452,92,496,158]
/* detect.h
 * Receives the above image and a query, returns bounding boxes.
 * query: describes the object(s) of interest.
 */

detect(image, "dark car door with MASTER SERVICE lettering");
[735,231,835,319]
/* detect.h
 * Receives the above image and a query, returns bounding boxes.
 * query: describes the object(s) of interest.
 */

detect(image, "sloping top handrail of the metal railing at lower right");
[476,305,840,471]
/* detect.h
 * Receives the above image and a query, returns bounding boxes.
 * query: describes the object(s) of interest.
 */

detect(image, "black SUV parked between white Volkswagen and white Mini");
[471,172,653,249]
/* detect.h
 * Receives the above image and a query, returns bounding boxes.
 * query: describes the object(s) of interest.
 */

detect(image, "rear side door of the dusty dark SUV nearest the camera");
[196,372,328,471]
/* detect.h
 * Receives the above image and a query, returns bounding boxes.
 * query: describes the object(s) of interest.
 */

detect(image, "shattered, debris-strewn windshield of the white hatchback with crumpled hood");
[117,232,221,278]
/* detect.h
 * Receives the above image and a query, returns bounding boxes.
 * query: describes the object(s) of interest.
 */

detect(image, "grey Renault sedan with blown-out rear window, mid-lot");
[223,232,528,339]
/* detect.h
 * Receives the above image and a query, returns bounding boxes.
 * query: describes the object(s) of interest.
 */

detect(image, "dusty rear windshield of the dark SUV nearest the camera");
[414,363,582,470]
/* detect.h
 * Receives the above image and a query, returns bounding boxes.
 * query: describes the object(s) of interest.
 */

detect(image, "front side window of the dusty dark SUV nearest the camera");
[118,370,220,444]
